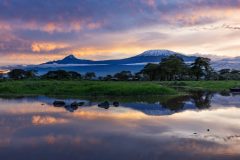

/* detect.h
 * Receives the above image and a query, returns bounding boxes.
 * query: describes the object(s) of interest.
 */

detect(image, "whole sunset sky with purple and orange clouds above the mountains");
[0,0,240,65]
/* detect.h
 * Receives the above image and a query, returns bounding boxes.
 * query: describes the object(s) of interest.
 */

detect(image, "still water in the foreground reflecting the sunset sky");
[0,93,240,160]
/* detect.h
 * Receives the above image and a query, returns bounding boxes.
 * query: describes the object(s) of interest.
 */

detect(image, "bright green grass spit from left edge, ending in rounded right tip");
[0,80,177,96]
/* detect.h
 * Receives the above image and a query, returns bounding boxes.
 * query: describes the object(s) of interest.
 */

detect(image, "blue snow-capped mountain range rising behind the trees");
[22,50,240,76]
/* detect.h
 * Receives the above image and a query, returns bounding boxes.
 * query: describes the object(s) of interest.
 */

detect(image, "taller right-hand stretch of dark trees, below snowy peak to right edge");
[140,55,240,81]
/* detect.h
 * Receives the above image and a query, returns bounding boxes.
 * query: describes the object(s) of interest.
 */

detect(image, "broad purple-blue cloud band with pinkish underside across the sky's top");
[0,0,240,33]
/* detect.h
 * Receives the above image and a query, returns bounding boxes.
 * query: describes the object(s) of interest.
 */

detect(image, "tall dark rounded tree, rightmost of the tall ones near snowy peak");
[191,57,212,80]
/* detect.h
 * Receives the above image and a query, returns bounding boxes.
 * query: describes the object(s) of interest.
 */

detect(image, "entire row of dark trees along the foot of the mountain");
[2,55,240,81]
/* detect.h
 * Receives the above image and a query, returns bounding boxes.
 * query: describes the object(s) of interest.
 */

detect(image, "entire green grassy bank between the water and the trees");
[0,80,240,96]
